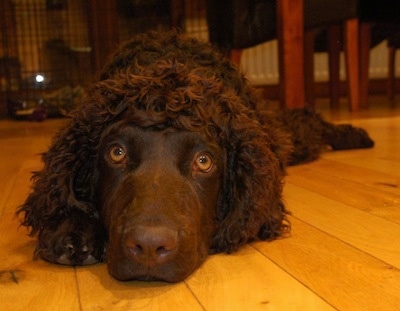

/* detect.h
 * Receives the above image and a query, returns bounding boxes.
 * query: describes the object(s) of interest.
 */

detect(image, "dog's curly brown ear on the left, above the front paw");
[17,119,96,235]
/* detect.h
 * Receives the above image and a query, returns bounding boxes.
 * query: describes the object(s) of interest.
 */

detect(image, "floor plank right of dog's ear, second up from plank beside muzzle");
[285,183,400,269]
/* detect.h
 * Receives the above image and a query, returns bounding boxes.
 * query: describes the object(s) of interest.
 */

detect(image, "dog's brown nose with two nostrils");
[125,226,178,267]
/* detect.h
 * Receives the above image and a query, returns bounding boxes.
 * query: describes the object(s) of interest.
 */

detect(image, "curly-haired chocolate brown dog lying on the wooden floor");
[17,32,374,282]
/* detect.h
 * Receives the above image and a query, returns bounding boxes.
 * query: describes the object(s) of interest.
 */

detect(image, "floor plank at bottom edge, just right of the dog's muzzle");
[187,247,333,311]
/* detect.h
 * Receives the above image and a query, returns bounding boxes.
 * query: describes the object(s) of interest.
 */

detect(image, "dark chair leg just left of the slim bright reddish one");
[328,25,341,109]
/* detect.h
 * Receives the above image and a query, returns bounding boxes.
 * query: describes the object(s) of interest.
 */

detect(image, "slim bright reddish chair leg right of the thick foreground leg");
[344,18,360,111]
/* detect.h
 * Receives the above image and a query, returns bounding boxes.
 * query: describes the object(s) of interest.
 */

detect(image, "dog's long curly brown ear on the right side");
[212,113,290,252]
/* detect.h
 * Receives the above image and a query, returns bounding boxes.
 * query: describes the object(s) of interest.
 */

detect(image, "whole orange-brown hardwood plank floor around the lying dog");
[0,99,400,311]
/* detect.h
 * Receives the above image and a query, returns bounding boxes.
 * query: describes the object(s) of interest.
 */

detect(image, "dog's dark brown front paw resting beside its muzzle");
[36,213,105,266]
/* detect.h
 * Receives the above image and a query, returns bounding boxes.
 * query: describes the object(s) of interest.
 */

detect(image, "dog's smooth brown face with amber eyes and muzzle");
[97,121,224,282]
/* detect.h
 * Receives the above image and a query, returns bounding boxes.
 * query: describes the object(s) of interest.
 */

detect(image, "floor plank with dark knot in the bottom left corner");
[0,206,80,310]
